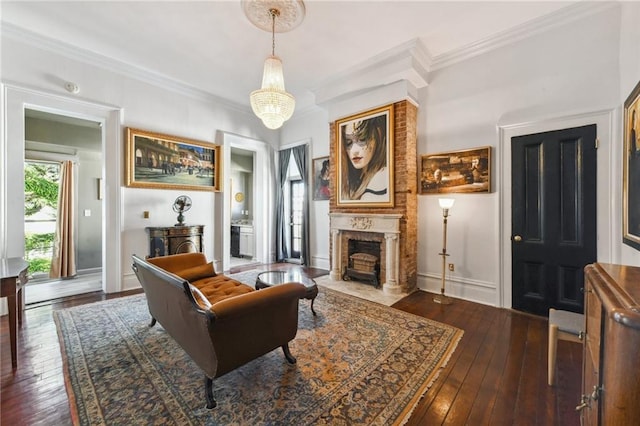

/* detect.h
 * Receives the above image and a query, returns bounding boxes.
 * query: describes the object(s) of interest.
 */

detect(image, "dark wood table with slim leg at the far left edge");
[0,257,29,368]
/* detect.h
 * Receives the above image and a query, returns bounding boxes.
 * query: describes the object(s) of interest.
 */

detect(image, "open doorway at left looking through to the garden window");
[24,109,104,304]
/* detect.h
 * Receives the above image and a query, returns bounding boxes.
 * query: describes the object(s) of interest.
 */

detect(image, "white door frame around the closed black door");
[496,110,620,308]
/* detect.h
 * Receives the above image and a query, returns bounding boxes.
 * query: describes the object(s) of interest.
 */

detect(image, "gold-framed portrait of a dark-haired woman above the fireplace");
[335,105,394,207]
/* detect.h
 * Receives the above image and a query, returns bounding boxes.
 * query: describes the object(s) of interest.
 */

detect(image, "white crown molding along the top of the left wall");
[0,22,252,114]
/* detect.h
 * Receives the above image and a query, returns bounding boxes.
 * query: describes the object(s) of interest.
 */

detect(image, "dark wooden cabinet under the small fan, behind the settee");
[145,225,204,257]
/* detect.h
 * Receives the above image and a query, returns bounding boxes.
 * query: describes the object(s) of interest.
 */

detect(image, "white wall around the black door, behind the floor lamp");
[282,3,640,306]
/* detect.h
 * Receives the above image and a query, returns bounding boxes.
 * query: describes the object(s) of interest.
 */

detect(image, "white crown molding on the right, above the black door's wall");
[430,1,619,71]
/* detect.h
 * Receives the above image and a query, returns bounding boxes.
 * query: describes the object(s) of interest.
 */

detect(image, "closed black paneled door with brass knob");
[511,124,597,315]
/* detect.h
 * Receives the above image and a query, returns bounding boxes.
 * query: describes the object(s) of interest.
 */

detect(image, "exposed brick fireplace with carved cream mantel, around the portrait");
[329,100,418,294]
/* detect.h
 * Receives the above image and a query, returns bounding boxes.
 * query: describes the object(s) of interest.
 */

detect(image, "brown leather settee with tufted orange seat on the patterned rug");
[132,253,306,408]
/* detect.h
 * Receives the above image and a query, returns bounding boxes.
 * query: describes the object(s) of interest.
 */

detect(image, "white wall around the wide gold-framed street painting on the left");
[0,33,278,292]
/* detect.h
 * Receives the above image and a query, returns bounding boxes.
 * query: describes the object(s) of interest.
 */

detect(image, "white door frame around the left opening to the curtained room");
[0,83,123,293]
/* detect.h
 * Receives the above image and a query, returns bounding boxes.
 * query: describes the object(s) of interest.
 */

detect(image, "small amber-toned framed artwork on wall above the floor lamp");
[419,146,491,194]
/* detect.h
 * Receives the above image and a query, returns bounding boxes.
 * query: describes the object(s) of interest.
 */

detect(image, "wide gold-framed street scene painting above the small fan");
[125,127,222,191]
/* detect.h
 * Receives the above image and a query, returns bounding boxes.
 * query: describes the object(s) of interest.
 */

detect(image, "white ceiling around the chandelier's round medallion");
[0,0,577,111]
